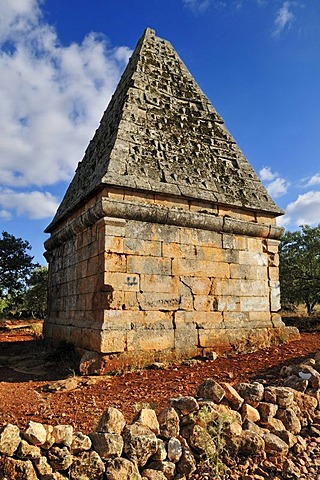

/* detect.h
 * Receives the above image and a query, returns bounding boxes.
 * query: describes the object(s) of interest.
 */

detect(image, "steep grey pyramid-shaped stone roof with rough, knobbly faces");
[47,28,283,230]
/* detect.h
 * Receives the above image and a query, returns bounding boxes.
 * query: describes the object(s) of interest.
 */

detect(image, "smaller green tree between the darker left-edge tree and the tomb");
[24,267,48,318]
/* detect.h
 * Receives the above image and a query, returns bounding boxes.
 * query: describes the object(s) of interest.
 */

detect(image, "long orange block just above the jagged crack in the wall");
[172,258,230,278]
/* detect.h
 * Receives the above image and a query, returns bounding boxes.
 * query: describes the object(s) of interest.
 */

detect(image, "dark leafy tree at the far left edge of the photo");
[0,232,38,298]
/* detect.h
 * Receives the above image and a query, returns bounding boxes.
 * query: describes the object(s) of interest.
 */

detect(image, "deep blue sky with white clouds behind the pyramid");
[0,0,320,264]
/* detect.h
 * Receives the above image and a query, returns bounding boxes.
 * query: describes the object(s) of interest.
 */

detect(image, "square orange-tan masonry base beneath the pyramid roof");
[45,190,298,372]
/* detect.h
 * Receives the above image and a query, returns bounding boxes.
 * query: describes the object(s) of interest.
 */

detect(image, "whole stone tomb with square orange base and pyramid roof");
[44,29,294,368]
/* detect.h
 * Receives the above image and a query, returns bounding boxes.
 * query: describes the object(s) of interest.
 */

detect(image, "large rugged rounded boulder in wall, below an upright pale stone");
[122,423,158,467]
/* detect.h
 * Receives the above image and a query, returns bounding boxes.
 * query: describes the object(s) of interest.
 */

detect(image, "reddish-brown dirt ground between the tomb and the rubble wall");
[0,329,320,433]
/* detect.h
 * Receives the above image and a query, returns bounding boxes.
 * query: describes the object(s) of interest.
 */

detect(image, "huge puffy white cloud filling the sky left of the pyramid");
[0,0,131,193]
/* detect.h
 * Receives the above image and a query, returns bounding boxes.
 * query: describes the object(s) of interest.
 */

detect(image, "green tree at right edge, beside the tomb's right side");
[279,224,320,315]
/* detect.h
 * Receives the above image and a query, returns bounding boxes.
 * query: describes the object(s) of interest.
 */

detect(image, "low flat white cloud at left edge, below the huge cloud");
[0,188,58,220]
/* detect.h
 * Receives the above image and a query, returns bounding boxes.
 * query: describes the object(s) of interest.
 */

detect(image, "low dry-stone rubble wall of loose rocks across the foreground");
[0,354,320,480]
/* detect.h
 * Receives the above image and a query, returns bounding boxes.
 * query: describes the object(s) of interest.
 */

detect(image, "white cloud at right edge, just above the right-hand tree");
[279,191,320,226]
